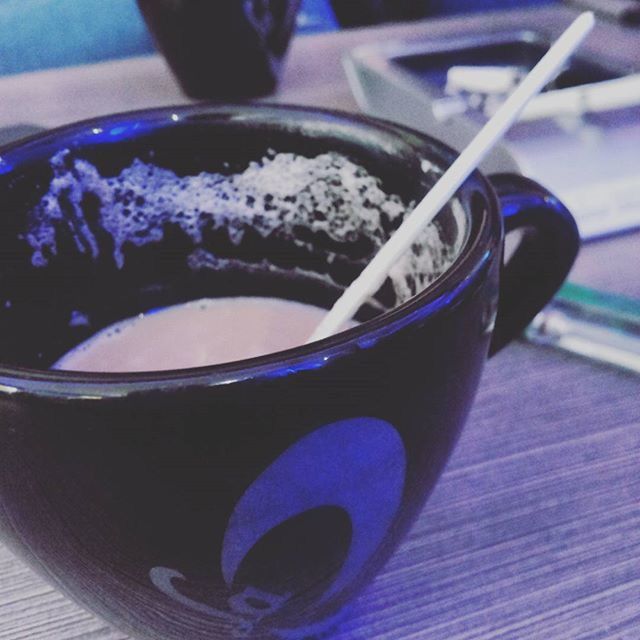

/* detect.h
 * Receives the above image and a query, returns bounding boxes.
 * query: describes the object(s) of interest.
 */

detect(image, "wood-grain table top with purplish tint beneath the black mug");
[0,6,640,640]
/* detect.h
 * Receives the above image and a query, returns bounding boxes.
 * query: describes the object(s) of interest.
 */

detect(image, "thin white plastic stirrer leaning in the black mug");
[307,11,595,342]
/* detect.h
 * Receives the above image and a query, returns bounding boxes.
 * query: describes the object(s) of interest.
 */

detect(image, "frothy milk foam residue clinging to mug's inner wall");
[26,150,464,302]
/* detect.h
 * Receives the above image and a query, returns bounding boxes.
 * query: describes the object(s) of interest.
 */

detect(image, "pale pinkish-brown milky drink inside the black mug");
[53,297,342,372]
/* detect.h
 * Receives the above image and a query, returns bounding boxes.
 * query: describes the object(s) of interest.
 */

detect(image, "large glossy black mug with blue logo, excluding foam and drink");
[0,106,578,640]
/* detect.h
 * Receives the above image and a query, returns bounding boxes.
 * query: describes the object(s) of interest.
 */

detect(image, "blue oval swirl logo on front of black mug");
[149,417,406,638]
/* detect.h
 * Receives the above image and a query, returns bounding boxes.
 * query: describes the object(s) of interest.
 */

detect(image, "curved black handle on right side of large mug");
[489,173,580,356]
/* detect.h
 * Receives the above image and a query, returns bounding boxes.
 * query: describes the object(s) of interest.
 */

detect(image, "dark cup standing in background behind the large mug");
[137,0,300,99]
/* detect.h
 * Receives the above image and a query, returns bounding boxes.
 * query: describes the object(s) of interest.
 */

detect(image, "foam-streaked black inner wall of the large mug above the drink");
[0,111,469,369]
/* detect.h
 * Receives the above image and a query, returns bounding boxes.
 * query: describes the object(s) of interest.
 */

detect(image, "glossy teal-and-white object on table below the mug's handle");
[525,283,640,373]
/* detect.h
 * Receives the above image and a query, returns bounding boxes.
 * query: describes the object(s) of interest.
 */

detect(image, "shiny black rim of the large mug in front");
[0,102,502,399]
